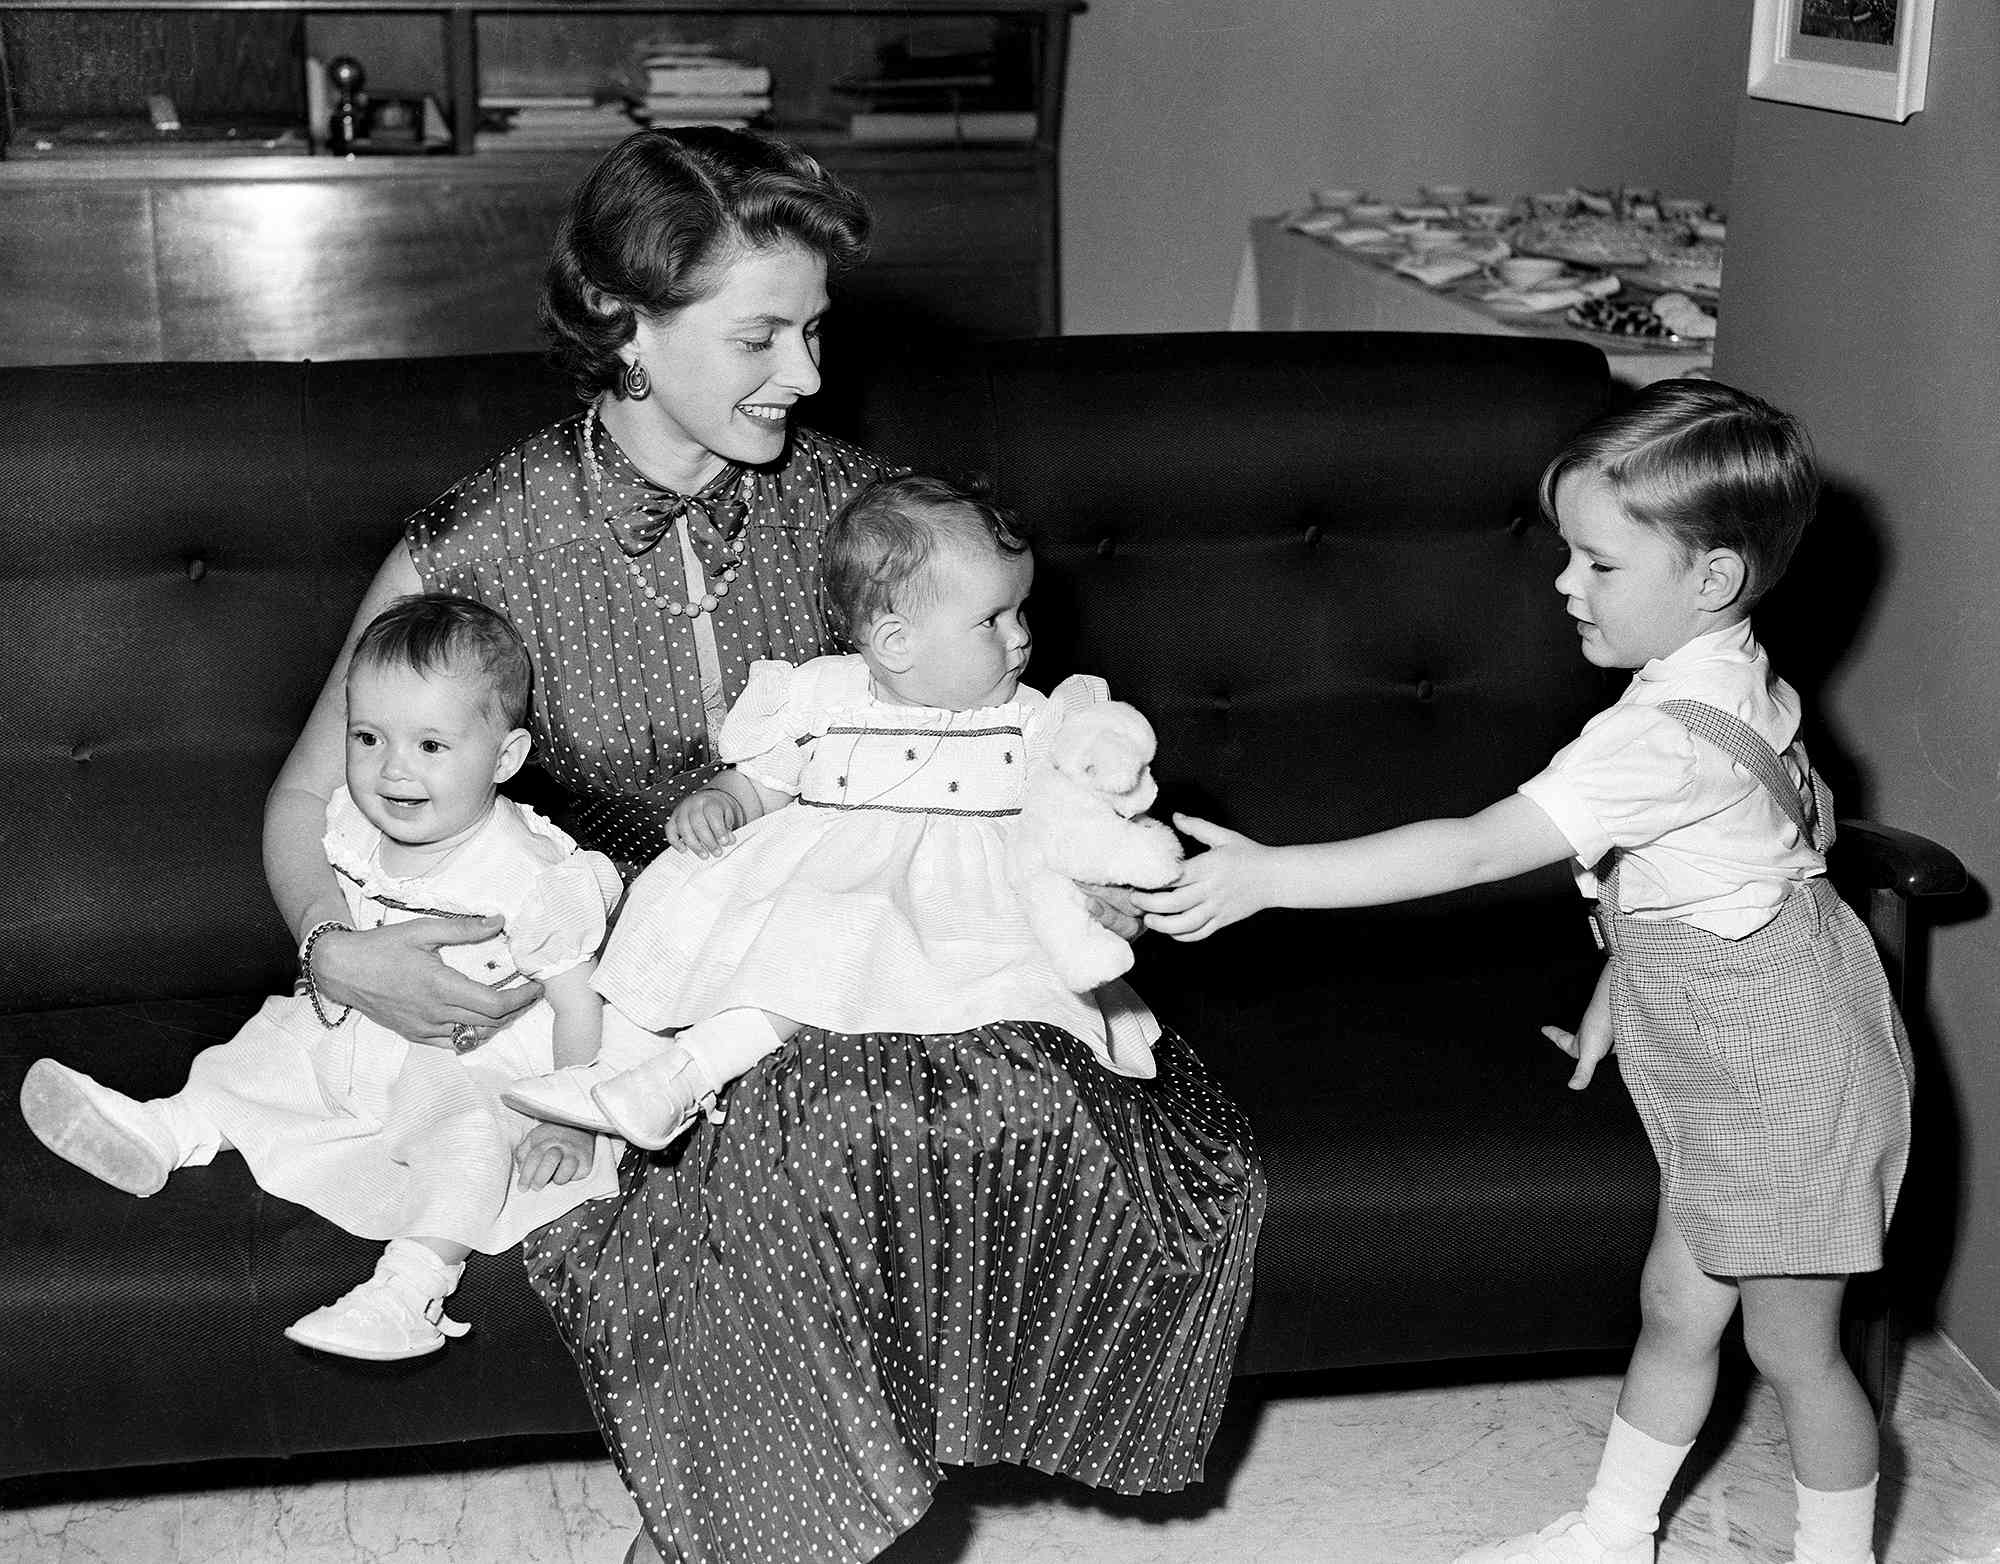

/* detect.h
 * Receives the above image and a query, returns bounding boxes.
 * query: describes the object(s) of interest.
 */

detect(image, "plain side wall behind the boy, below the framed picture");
[1716,0,2000,1380]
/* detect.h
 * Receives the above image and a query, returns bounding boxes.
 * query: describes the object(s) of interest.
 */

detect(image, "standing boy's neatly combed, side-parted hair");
[1540,380,1820,608]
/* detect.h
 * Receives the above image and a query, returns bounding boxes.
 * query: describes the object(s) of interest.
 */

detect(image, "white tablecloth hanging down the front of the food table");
[1230,218,1714,386]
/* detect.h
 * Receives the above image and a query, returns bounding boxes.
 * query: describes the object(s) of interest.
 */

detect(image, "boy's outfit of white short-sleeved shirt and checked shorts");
[1522,630,1912,1276]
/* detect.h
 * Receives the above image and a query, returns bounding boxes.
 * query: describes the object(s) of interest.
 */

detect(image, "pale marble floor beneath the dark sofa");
[0,1334,2000,1564]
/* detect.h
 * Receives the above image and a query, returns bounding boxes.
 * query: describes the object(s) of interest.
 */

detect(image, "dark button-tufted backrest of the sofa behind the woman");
[0,334,1608,1010]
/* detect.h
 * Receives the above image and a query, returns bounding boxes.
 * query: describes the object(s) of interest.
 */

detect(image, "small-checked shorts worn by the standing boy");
[1602,878,1912,1276]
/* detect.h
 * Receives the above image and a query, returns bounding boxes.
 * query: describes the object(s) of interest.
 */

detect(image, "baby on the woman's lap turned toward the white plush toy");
[506,476,1158,1148]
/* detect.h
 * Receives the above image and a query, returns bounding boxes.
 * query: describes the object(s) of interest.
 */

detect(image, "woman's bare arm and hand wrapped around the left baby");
[264,544,542,1046]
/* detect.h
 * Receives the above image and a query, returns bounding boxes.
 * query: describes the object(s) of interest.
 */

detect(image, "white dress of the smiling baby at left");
[180,788,618,1254]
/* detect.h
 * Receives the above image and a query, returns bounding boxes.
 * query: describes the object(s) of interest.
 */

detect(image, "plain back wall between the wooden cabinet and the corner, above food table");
[1062,0,1748,332]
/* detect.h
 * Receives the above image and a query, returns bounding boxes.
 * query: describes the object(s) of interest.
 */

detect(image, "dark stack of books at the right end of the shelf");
[836,28,1038,142]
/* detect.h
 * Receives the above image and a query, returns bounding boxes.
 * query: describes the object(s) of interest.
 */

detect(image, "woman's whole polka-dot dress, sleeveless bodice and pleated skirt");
[406,418,1264,1564]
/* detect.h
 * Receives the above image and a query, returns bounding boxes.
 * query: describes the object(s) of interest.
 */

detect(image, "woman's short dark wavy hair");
[540,126,870,402]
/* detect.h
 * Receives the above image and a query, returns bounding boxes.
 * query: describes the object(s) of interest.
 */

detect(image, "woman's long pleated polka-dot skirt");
[526,1022,1264,1564]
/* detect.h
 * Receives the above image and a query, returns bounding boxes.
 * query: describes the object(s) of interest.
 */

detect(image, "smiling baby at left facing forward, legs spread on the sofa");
[20,594,644,1360]
